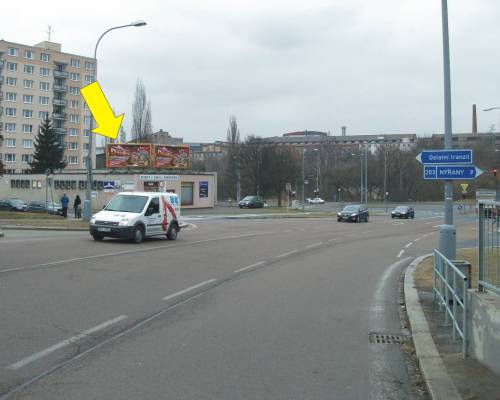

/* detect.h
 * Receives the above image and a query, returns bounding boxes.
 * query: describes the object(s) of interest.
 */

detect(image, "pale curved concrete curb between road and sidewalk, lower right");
[404,254,462,400]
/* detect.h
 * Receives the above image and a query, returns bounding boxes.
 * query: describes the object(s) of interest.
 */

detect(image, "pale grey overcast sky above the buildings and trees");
[0,0,500,142]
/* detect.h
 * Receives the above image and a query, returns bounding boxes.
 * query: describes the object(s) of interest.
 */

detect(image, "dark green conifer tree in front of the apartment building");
[30,118,66,173]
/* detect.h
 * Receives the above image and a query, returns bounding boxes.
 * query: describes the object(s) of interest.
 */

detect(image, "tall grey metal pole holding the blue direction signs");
[439,0,457,260]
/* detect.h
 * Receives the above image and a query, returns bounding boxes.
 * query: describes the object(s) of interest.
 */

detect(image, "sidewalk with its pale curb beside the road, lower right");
[405,258,500,400]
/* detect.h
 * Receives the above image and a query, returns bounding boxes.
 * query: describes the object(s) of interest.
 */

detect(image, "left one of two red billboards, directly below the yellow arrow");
[106,143,151,168]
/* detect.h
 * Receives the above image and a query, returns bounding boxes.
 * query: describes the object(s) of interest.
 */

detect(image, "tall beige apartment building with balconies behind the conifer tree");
[0,40,96,174]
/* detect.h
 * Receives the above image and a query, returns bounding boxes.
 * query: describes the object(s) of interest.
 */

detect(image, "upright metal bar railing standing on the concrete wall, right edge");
[477,200,500,295]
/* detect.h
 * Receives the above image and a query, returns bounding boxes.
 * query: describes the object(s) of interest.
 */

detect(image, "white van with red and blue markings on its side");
[89,192,181,243]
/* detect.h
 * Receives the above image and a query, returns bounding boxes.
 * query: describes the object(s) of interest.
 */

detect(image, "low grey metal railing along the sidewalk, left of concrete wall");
[432,250,469,358]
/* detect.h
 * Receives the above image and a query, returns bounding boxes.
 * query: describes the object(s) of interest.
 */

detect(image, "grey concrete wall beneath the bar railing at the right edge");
[468,289,500,375]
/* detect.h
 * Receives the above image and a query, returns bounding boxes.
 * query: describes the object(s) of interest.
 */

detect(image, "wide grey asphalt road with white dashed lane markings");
[0,217,474,400]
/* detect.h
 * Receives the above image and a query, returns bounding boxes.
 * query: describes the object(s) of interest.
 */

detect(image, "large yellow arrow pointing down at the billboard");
[80,81,125,139]
